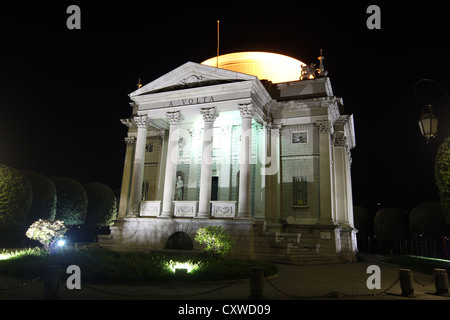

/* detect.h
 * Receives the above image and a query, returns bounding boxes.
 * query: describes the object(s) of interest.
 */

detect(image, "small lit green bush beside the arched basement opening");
[195,226,233,259]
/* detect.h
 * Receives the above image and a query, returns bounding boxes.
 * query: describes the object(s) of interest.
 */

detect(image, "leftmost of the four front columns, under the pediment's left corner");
[128,115,150,217]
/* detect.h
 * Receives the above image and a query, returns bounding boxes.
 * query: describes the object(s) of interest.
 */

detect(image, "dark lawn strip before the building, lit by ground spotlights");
[0,248,278,282]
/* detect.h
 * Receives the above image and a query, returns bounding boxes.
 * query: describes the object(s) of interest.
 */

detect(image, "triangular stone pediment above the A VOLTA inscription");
[129,62,257,97]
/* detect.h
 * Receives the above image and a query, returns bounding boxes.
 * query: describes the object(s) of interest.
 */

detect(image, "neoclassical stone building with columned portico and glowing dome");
[99,52,357,264]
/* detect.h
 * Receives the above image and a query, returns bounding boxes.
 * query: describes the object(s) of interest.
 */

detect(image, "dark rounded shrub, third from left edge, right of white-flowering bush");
[51,178,87,226]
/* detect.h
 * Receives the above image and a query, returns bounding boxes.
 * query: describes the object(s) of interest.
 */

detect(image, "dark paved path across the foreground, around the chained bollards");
[0,255,450,301]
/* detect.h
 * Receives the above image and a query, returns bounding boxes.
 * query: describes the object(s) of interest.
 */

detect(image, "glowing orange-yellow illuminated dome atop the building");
[202,51,306,83]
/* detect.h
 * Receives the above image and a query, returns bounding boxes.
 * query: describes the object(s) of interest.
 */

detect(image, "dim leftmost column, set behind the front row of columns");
[118,137,136,219]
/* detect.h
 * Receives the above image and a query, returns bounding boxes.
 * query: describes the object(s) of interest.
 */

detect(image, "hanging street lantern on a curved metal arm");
[414,79,450,143]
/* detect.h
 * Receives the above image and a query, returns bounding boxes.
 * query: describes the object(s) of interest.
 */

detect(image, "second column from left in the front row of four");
[160,111,184,218]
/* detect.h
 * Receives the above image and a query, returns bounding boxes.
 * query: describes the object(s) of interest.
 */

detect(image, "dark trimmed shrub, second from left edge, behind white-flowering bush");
[22,171,56,225]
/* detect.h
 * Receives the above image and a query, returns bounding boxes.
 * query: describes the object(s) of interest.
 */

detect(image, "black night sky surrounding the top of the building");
[0,1,450,212]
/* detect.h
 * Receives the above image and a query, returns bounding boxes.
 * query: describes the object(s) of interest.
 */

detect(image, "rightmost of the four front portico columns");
[238,103,256,219]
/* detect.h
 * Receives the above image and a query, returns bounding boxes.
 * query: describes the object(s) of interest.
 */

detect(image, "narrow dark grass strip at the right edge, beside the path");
[383,254,450,272]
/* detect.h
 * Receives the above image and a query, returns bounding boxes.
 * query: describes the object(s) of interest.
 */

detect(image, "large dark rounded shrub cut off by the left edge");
[0,165,33,225]
